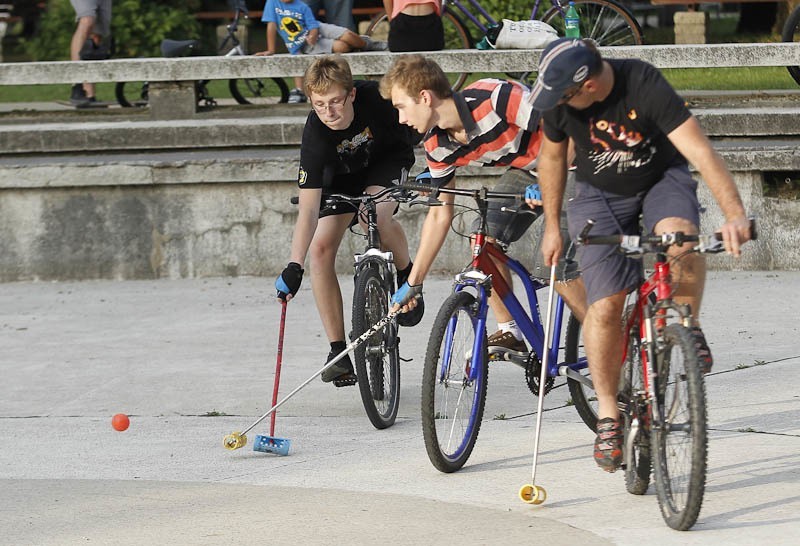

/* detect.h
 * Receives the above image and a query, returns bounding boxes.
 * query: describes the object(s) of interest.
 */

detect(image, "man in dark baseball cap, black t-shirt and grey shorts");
[530,38,750,472]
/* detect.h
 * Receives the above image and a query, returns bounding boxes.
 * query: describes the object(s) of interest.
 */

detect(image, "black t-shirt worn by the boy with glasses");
[298,81,422,195]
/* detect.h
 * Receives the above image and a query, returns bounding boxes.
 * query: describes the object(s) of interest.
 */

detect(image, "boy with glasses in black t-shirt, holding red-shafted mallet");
[275,55,423,387]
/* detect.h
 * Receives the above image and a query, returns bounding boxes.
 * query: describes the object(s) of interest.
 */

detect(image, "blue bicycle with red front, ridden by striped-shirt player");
[404,183,597,472]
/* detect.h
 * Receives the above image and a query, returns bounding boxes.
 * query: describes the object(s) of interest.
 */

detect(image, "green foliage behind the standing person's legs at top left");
[25,0,201,61]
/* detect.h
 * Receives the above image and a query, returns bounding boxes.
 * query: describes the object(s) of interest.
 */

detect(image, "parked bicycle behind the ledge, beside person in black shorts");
[367,0,644,89]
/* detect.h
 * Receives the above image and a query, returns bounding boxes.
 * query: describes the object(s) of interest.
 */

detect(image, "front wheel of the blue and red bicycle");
[422,291,489,473]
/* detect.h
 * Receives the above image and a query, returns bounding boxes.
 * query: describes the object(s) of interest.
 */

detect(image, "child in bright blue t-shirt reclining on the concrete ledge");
[256,0,386,104]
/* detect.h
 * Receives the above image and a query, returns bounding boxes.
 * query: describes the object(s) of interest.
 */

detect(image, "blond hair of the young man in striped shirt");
[381,55,453,99]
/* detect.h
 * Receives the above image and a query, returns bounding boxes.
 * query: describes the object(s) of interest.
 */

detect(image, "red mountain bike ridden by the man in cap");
[578,222,755,531]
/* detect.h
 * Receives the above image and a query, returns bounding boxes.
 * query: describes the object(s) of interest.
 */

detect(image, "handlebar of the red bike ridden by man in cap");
[577,218,758,254]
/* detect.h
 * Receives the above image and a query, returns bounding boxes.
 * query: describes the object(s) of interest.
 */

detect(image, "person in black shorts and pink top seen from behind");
[383,0,444,52]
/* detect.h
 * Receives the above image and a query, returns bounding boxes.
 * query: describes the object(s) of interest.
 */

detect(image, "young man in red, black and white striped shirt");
[381,55,585,358]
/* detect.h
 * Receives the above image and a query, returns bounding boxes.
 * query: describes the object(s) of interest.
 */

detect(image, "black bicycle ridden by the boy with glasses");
[292,186,416,429]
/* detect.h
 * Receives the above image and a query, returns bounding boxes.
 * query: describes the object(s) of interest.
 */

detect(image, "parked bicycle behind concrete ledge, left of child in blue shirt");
[114,0,289,107]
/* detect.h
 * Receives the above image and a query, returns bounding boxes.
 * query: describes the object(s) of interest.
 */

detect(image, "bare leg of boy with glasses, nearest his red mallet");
[309,214,353,342]
